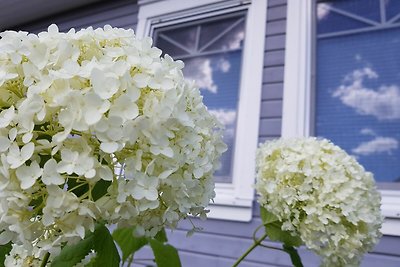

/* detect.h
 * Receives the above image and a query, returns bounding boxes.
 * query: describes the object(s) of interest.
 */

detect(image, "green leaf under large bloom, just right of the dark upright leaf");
[112,227,148,261]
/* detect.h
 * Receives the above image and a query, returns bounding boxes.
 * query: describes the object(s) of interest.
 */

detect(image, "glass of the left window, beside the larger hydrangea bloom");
[155,13,244,183]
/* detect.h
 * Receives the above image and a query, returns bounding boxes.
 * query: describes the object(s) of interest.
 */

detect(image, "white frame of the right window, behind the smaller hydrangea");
[282,0,400,236]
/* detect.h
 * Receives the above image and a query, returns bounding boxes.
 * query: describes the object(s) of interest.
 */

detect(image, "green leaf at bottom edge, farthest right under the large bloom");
[149,239,182,267]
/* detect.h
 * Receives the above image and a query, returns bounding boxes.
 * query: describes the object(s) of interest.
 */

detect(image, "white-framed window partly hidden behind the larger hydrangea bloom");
[136,0,267,221]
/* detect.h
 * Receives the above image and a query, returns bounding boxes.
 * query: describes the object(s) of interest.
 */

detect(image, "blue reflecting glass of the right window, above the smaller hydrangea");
[315,0,400,189]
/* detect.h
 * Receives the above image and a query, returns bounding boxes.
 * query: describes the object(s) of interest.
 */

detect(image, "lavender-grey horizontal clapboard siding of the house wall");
[8,0,400,267]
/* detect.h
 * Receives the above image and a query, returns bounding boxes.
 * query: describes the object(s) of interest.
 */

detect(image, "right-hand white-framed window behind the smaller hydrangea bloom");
[282,0,400,235]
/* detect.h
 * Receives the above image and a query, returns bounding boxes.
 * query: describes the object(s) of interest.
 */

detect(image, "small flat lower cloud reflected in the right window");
[352,136,399,156]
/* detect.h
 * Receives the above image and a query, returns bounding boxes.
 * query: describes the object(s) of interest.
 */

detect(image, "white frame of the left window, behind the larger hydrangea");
[136,0,268,221]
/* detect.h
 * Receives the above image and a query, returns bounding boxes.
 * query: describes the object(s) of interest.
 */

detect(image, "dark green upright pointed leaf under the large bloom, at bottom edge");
[94,225,121,267]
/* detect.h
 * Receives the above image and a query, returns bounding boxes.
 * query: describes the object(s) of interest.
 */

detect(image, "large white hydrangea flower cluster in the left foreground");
[0,25,226,262]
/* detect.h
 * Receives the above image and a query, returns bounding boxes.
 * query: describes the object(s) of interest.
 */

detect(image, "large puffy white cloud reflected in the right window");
[332,67,400,120]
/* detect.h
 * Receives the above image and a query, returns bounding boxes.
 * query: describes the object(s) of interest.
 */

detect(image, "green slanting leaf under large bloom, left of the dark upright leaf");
[51,233,94,267]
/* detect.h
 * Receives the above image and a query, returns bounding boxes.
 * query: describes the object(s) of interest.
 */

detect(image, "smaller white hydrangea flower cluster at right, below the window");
[256,137,382,267]
